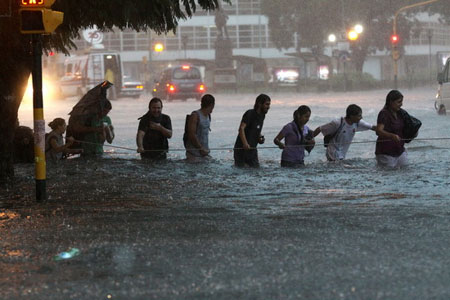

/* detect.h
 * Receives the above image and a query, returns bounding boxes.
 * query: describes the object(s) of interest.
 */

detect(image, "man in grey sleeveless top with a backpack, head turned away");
[185,94,215,162]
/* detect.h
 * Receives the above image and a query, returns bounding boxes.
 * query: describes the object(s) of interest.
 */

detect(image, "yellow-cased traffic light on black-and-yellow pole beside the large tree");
[19,0,64,34]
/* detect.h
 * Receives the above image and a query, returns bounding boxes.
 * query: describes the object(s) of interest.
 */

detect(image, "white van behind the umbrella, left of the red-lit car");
[59,51,123,99]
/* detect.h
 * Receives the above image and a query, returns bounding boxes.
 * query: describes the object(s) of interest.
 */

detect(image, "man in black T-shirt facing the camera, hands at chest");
[136,97,172,160]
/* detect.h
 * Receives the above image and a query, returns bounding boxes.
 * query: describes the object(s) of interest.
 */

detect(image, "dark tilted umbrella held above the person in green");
[69,80,113,116]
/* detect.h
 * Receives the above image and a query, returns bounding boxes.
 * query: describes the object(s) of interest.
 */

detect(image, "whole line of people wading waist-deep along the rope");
[33,90,420,168]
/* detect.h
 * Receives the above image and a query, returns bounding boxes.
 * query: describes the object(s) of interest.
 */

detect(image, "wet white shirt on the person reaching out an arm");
[320,118,372,160]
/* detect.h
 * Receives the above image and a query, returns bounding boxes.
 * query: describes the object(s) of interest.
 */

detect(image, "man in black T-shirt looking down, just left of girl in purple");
[234,94,270,168]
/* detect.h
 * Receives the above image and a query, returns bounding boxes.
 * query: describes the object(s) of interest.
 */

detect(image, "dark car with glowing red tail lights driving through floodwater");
[152,65,206,101]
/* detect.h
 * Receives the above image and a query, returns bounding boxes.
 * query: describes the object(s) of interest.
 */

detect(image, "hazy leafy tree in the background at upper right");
[262,0,442,72]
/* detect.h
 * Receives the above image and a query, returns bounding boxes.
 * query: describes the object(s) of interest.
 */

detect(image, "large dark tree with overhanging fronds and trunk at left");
[0,0,219,183]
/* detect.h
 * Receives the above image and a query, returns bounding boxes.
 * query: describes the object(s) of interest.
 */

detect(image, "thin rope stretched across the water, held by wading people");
[75,137,450,152]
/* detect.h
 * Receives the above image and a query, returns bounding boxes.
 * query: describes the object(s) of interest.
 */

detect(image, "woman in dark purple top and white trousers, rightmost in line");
[375,90,408,168]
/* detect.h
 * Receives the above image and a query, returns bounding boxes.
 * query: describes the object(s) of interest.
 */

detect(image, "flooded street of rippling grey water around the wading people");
[0,87,450,299]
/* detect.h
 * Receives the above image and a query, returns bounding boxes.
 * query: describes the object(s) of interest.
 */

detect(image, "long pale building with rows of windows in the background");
[68,0,450,84]
